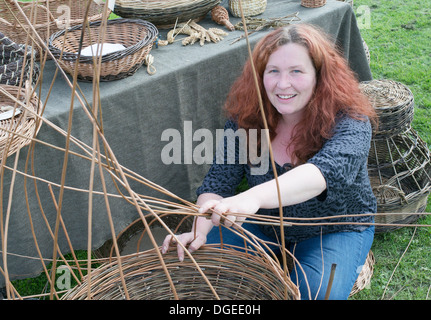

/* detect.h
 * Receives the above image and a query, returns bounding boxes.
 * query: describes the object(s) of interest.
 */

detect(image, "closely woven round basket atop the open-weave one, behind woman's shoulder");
[360,80,414,137]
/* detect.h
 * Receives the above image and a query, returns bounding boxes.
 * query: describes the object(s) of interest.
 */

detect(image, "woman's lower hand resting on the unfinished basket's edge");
[162,231,207,261]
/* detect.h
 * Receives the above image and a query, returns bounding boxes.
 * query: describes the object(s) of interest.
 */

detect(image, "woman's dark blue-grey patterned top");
[196,116,377,243]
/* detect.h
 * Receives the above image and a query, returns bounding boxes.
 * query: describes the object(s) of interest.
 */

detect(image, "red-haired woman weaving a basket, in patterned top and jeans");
[162,24,376,299]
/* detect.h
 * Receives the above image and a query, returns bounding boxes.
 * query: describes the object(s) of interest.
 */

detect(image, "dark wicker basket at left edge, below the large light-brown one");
[0,32,40,86]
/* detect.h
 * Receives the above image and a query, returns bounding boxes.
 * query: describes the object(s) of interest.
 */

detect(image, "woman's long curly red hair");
[225,24,377,165]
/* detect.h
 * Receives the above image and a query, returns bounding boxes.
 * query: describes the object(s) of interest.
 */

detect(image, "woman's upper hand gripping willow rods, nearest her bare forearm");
[199,193,260,227]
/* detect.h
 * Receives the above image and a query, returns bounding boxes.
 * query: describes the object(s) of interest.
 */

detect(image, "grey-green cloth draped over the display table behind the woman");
[0,0,371,287]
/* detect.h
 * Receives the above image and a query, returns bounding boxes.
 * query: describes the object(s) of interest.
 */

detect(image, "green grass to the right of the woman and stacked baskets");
[352,0,431,300]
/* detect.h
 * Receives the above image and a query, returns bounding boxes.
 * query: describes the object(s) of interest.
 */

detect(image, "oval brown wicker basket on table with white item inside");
[49,19,158,81]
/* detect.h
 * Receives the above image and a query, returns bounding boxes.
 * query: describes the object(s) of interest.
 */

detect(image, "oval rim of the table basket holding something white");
[49,18,158,63]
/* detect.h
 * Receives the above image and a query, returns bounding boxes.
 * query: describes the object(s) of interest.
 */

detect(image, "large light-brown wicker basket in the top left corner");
[0,0,103,53]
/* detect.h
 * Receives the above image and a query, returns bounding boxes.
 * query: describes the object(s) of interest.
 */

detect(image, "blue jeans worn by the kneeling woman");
[207,223,374,300]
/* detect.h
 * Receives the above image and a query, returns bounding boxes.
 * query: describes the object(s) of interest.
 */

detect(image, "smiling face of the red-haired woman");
[263,43,316,120]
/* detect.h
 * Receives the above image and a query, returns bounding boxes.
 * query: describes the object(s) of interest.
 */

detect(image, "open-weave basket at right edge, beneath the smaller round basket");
[368,128,431,232]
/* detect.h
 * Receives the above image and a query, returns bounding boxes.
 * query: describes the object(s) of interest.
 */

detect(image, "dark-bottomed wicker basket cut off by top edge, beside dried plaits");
[114,0,221,29]
